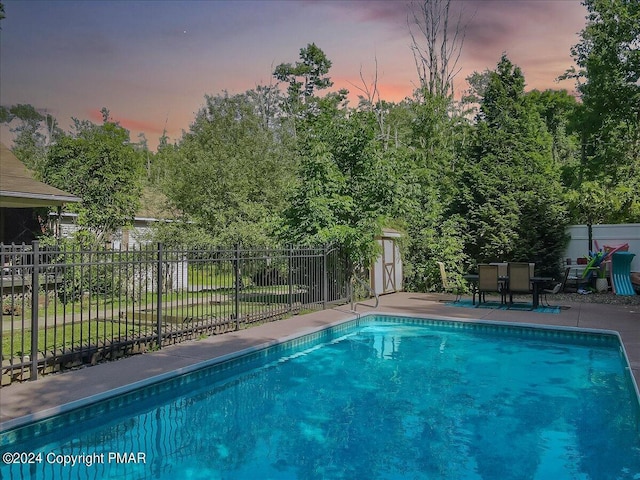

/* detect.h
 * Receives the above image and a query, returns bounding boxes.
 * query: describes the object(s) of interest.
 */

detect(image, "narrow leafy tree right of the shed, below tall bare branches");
[398,91,466,290]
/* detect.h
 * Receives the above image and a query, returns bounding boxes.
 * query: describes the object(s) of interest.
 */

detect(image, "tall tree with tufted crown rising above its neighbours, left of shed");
[274,44,380,265]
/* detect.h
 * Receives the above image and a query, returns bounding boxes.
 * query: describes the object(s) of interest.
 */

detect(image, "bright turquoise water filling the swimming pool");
[0,317,640,480]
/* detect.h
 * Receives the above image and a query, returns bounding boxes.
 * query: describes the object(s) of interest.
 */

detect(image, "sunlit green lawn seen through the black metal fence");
[2,264,310,358]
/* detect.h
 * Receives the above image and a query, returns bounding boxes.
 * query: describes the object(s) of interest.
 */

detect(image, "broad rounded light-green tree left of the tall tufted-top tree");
[158,93,296,246]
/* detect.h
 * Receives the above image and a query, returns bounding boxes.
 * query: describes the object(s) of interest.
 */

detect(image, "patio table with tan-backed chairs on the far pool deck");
[464,262,560,310]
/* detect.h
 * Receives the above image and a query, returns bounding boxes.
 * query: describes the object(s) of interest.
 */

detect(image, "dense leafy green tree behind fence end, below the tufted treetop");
[279,101,382,266]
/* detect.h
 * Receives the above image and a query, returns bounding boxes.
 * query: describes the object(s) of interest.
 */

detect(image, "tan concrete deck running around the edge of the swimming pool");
[0,293,640,431]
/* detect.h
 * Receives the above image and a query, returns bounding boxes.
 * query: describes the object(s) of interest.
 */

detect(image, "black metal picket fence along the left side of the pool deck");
[0,242,350,386]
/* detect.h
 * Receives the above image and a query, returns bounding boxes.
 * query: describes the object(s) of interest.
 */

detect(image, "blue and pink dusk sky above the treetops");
[0,0,586,149]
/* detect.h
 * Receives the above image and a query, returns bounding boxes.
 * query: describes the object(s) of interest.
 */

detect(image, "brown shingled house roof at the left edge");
[0,143,82,208]
